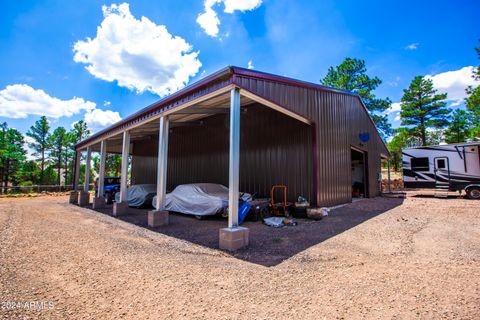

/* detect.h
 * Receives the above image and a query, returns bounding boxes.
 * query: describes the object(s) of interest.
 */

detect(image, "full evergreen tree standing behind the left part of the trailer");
[400,76,450,145]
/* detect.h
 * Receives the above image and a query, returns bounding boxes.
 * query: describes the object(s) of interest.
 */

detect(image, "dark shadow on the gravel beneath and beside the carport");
[91,198,403,266]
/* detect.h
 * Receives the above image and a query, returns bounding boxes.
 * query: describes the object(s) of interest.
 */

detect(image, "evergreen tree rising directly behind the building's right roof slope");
[320,58,392,138]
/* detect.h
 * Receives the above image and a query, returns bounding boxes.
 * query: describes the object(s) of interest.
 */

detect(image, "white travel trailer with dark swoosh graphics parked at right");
[402,142,480,199]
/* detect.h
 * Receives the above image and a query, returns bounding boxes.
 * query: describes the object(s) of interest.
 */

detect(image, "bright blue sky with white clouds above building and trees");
[0,0,480,138]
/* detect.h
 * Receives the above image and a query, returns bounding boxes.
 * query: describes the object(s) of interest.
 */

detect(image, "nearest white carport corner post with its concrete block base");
[219,88,249,251]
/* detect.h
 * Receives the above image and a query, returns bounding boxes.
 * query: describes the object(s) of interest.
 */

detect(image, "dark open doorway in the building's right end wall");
[351,148,368,200]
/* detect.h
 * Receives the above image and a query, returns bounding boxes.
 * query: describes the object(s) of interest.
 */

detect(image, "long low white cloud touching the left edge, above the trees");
[0,84,96,119]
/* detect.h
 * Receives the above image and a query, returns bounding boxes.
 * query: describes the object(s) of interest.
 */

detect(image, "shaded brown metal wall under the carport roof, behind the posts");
[132,105,314,201]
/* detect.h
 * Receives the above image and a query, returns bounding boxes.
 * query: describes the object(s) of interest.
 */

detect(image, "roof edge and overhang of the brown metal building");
[75,67,389,152]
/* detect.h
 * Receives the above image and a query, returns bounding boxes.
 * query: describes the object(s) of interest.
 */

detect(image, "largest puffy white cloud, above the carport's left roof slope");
[73,3,202,96]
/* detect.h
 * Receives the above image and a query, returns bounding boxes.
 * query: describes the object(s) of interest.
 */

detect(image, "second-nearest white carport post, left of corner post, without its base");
[156,116,169,211]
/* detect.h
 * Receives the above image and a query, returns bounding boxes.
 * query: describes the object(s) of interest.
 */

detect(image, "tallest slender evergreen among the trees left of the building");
[27,116,50,183]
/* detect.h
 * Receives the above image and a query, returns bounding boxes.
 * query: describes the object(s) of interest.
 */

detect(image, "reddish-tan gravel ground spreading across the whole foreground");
[0,194,480,319]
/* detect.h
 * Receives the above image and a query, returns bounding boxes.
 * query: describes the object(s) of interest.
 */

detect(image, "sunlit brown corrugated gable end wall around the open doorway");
[235,76,388,206]
